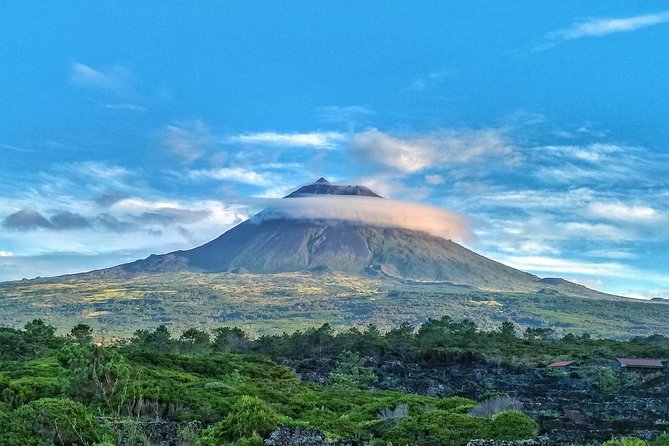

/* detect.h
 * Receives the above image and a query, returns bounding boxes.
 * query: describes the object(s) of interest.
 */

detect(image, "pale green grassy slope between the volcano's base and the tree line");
[0,273,669,337]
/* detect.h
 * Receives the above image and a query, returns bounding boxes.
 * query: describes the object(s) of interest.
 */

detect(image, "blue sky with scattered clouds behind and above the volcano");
[0,0,669,297]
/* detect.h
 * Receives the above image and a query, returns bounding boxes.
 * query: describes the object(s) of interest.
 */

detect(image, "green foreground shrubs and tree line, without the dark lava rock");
[0,317,669,446]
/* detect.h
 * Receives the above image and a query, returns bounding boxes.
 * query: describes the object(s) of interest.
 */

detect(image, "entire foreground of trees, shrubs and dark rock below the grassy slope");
[0,316,669,446]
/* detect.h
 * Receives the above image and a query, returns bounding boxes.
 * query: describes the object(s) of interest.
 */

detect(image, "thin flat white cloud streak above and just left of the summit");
[225,132,346,149]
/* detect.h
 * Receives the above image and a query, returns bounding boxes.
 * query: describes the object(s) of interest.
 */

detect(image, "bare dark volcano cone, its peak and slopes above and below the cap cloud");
[64,178,608,297]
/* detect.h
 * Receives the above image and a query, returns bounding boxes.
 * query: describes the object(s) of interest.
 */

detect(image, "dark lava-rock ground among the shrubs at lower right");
[285,358,669,445]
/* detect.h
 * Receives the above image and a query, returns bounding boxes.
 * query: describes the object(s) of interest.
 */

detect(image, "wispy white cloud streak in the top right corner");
[548,11,669,40]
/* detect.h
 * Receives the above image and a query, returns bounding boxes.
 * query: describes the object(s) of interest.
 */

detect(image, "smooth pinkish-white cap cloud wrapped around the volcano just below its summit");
[252,195,471,240]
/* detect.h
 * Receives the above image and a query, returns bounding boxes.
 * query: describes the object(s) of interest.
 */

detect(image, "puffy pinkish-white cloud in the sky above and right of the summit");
[351,128,514,173]
